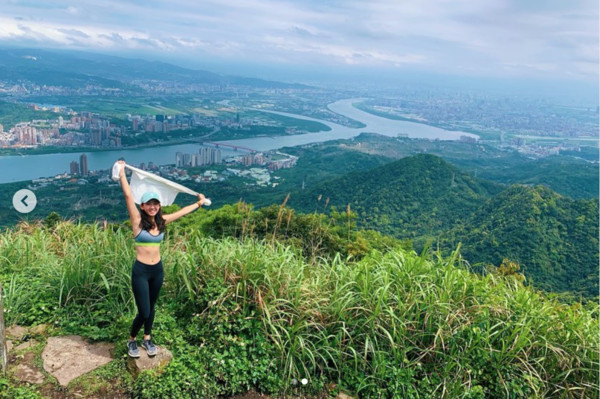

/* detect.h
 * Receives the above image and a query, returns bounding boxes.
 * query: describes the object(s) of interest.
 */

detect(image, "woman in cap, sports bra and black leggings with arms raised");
[118,161,206,357]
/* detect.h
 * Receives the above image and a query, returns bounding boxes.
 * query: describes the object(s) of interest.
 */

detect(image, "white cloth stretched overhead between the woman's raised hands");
[112,162,204,205]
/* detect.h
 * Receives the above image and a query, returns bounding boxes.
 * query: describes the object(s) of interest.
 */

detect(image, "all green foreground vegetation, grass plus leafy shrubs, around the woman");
[0,216,599,399]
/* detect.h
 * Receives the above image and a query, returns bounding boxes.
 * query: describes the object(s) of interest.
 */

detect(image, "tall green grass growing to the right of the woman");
[162,234,598,397]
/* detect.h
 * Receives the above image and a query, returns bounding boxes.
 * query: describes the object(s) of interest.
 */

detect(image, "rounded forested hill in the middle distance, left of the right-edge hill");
[290,154,502,239]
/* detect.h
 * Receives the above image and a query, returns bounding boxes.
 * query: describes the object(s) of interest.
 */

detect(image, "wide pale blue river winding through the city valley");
[0,99,477,183]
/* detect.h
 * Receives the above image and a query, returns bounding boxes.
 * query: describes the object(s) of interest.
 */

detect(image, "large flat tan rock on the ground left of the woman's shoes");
[42,335,114,386]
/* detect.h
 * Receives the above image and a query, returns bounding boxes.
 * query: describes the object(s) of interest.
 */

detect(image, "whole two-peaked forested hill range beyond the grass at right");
[290,155,598,297]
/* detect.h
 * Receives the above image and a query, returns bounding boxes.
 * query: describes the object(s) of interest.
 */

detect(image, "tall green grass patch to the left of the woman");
[0,223,135,330]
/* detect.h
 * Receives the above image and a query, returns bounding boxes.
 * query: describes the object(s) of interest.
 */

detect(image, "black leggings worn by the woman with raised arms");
[131,259,165,338]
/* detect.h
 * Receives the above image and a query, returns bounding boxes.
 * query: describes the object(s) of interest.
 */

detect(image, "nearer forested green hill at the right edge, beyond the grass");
[444,185,599,296]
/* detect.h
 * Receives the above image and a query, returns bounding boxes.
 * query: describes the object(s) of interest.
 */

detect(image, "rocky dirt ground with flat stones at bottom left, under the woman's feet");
[1,325,351,399]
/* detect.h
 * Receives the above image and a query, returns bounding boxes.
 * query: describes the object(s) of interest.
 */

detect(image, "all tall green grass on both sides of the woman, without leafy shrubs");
[0,223,599,398]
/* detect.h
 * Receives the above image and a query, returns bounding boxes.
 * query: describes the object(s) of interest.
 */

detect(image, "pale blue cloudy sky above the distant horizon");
[0,0,599,82]
